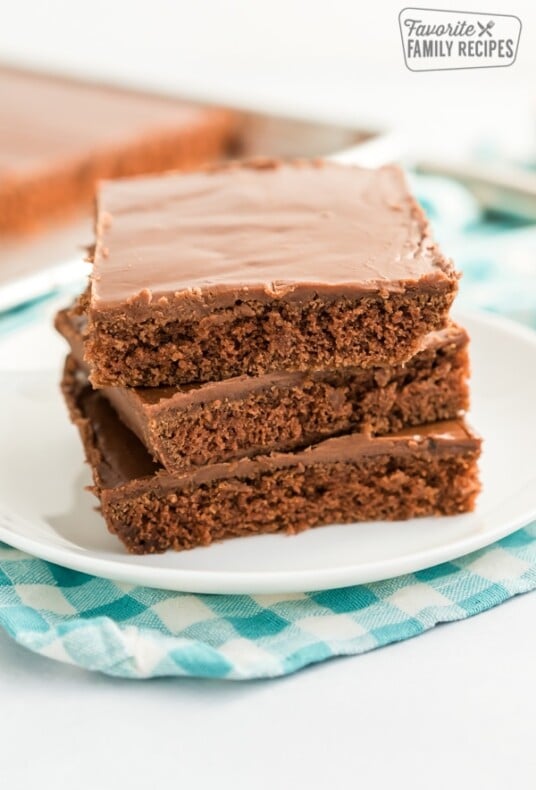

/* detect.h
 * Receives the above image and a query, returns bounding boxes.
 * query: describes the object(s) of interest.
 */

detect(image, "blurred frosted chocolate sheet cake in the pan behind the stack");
[0,68,237,233]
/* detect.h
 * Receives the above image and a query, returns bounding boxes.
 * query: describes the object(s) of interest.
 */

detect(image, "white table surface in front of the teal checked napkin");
[0,594,536,790]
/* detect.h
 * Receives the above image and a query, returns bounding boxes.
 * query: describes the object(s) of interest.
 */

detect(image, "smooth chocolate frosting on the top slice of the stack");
[90,161,456,314]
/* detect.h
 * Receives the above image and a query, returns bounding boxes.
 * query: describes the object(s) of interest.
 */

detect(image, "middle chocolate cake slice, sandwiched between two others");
[56,310,469,473]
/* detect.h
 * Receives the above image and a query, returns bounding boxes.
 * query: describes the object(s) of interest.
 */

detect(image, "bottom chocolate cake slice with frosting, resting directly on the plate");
[62,357,480,554]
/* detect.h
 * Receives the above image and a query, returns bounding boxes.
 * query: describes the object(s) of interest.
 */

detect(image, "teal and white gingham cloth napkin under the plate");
[0,178,536,680]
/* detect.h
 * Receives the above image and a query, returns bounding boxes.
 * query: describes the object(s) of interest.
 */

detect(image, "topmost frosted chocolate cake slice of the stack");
[85,161,457,387]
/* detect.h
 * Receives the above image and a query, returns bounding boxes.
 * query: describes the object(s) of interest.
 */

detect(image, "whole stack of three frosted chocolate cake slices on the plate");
[56,161,480,553]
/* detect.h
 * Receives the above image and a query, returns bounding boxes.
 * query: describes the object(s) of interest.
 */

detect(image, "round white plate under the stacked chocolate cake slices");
[0,315,536,593]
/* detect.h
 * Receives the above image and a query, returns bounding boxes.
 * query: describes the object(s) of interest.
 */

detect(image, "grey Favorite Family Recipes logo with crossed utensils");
[398,8,521,71]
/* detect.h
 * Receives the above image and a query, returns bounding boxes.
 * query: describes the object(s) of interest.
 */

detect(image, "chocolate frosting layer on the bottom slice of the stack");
[64,358,481,491]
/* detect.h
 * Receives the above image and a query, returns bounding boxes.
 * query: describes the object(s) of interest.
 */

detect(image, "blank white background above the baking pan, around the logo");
[0,0,536,159]
